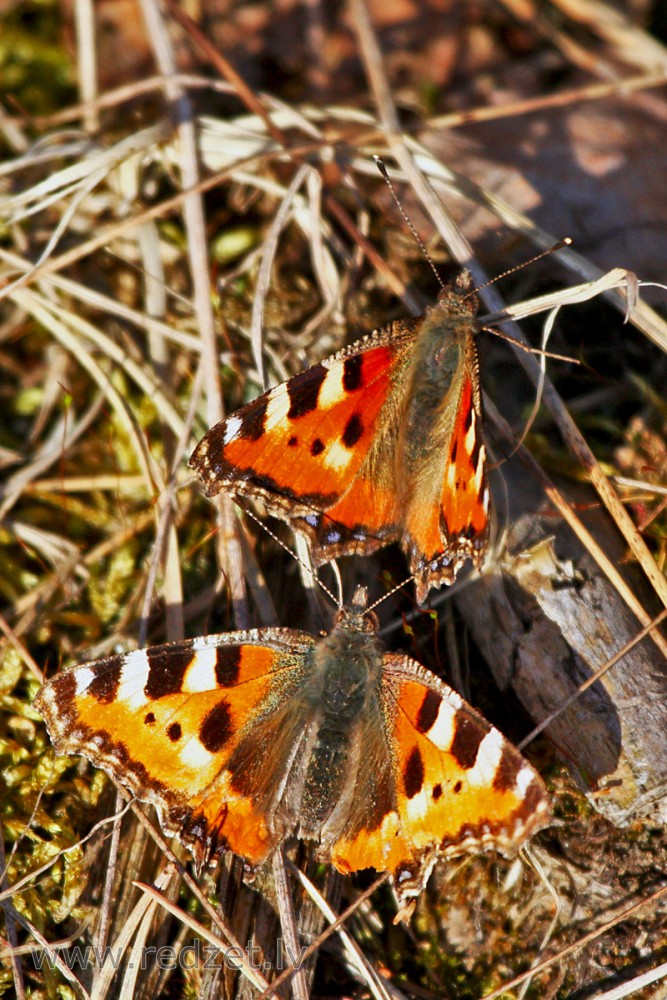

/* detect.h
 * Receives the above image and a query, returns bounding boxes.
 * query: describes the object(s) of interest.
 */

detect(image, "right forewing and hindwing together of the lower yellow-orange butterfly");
[331,654,549,900]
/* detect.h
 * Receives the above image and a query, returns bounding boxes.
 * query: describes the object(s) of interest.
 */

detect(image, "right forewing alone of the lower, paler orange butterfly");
[383,654,549,853]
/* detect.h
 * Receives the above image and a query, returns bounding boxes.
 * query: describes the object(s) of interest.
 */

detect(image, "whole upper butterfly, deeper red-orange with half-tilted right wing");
[190,271,490,604]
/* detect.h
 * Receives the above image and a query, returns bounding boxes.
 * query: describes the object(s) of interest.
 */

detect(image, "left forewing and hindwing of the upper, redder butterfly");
[190,321,419,564]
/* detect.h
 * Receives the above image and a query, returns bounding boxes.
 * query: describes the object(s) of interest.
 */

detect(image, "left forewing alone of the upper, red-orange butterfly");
[190,346,402,517]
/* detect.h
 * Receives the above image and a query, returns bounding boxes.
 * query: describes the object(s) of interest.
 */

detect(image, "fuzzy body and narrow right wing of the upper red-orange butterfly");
[399,282,489,604]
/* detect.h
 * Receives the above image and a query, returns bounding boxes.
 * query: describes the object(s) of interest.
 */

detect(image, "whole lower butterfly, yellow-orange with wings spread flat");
[35,588,549,904]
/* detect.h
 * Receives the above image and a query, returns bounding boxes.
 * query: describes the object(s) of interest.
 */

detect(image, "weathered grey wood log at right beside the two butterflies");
[456,457,667,826]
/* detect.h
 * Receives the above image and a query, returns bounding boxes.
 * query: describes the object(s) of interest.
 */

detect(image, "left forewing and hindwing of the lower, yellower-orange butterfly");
[35,629,314,864]
